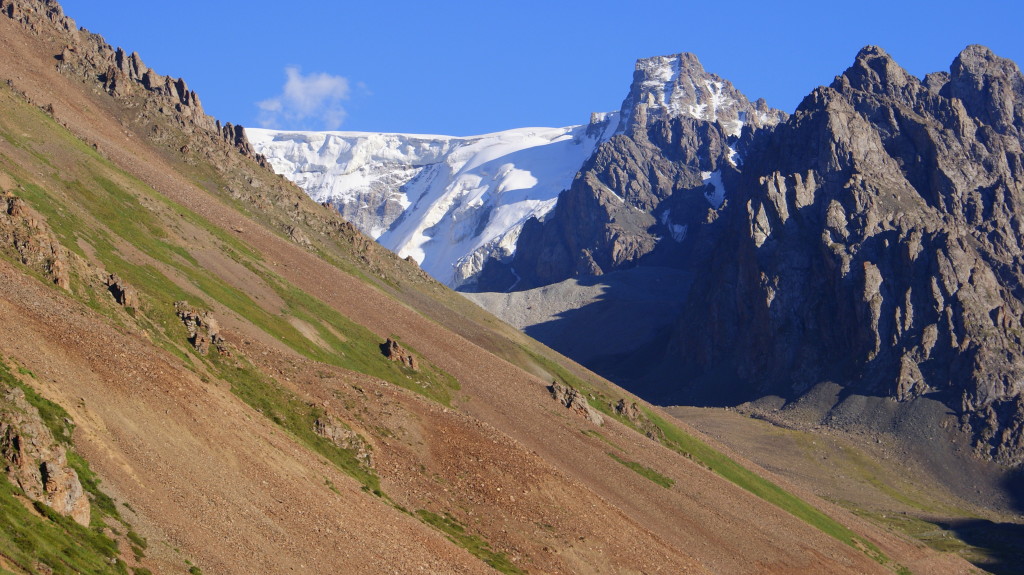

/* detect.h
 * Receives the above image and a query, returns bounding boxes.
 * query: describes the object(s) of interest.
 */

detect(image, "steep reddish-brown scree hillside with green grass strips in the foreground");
[0,0,970,575]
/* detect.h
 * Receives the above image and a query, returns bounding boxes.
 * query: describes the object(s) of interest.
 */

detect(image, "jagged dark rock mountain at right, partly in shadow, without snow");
[668,46,1024,463]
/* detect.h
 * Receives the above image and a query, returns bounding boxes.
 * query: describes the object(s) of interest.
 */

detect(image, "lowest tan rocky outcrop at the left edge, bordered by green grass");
[0,380,90,526]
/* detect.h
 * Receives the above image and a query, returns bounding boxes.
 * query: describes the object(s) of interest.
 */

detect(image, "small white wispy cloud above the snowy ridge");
[256,68,350,130]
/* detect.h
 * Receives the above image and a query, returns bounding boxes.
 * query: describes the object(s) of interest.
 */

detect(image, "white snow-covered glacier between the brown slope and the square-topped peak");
[246,113,618,288]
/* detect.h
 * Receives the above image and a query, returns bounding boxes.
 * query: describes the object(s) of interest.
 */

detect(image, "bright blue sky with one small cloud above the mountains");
[61,0,1024,135]
